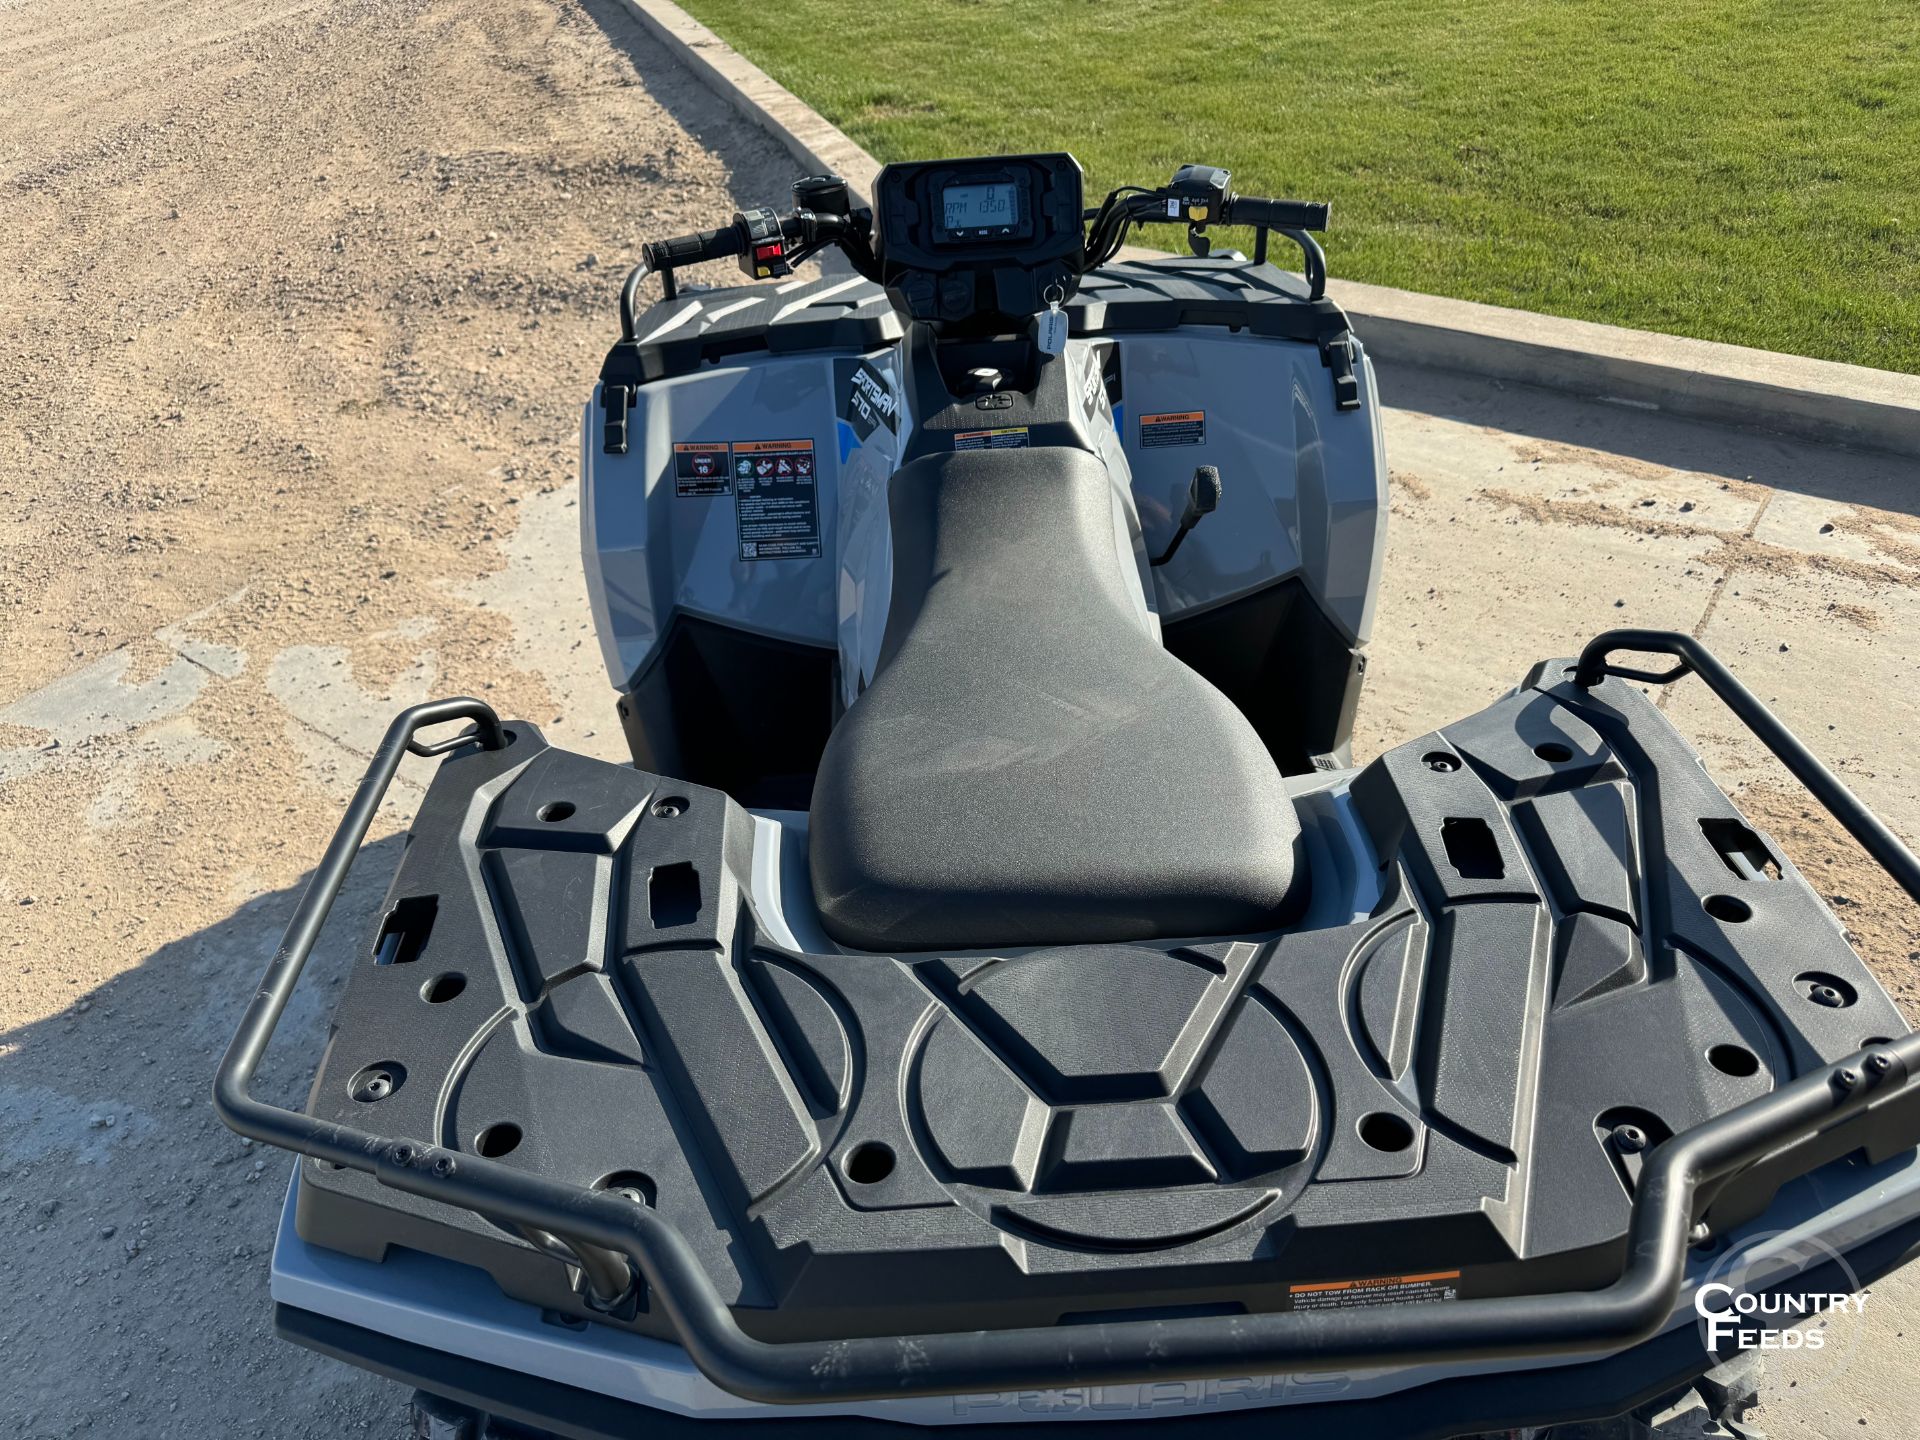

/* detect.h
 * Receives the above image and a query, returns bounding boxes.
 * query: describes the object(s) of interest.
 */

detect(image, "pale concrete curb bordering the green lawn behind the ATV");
[620,0,1920,457]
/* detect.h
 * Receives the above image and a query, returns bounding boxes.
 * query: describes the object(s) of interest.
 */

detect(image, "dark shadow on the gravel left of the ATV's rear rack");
[0,835,411,1440]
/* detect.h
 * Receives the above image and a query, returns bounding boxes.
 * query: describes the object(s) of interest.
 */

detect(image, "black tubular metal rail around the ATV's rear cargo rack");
[213,630,1920,1404]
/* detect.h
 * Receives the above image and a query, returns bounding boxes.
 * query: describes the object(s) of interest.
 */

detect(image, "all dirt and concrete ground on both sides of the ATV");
[0,0,1920,1440]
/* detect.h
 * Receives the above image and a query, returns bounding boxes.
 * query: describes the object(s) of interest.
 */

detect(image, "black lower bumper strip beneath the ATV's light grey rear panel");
[275,1217,1920,1440]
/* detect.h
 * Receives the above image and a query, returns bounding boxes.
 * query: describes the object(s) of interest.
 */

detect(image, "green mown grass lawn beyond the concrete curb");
[682,0,1920,371]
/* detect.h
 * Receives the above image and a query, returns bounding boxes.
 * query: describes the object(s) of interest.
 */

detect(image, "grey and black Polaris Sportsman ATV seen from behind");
[215,154,1920,1440]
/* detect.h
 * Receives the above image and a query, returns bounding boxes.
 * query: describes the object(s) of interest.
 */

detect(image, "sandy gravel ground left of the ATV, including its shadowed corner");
[0,0,793,1440]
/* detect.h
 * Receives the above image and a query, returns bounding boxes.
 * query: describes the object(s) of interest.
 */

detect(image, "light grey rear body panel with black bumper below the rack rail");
[273,1154,1920,1440]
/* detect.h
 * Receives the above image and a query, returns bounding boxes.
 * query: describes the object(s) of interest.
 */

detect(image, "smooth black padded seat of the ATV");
[808,447,1300,950]
